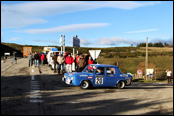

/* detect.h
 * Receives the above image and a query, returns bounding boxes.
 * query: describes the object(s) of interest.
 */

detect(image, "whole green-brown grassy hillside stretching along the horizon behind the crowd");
[1,43,173,78]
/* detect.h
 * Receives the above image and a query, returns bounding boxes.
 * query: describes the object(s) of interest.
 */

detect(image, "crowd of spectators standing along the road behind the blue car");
[28,52,96,74]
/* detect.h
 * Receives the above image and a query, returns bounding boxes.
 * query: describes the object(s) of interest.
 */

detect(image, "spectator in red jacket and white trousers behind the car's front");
[65,53,74,73]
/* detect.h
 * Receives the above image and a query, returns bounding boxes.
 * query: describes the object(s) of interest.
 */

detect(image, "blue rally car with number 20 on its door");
[62,64,132,89]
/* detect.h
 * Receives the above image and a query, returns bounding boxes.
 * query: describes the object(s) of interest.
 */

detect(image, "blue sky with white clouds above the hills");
[1,1,173,48]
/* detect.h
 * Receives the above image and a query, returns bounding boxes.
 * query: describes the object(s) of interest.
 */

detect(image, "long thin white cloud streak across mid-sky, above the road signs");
[17,23,109,34]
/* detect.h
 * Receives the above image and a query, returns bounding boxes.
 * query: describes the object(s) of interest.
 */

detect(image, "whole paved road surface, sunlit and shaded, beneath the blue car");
[1,58,173,115]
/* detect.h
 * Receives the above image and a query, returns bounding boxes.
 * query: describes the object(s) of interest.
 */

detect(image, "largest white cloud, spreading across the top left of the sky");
[1,1,160,28]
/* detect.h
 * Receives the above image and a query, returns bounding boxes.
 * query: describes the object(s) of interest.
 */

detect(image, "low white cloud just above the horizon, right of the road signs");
[96,37,140,46]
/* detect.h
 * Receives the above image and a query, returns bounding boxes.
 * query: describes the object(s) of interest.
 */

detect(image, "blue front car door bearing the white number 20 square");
[93,67,106,87]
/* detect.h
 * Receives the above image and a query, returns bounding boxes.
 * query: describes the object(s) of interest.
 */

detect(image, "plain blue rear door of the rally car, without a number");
[105,67,118,86]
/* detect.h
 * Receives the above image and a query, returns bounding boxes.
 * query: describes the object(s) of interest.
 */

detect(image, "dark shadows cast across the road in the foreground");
[1,74,173,115]
